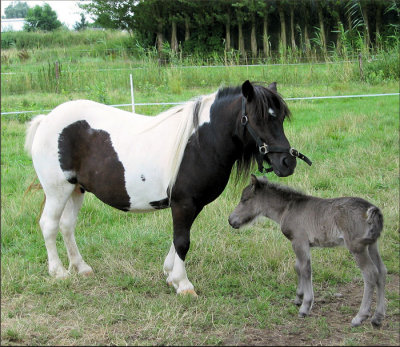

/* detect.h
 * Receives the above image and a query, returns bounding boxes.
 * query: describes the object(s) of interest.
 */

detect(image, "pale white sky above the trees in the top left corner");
[1,0,92,29]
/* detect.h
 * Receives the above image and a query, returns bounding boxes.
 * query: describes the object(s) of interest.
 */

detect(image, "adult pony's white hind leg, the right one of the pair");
[60,186,93,275]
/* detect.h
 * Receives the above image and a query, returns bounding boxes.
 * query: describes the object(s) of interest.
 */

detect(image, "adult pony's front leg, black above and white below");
[167,204,198,296]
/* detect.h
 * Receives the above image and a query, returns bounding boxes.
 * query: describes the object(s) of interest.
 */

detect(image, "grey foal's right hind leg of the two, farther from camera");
[368,242,387,327]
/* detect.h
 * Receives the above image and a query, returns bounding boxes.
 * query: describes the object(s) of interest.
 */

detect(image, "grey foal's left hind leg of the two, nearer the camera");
[351,247,378,326]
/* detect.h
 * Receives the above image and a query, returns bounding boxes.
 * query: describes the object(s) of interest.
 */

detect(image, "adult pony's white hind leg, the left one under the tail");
[39,183,74,278]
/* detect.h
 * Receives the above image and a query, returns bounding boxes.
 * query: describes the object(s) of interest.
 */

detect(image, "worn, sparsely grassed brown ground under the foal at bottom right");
[223,274,400,346]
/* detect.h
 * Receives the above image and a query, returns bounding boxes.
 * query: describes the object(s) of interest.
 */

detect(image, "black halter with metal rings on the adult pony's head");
[240,97,312,173]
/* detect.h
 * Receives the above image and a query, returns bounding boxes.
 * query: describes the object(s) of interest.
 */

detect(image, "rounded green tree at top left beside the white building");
[24,4,61,31]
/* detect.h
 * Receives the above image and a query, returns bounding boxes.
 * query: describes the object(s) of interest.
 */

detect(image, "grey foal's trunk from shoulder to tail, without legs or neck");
[281,195,383,251]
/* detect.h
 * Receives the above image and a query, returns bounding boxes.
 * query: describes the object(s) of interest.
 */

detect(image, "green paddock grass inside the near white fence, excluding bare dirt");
[1,87,399,345]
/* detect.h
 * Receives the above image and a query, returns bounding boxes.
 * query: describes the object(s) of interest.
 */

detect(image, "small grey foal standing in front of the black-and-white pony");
[229,175,386,326]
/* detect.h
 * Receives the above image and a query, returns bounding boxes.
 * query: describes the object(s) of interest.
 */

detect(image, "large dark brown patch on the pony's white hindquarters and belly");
[58,120,130,211]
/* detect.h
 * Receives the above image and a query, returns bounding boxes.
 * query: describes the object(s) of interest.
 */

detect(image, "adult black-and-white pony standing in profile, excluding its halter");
[25,81,296,295]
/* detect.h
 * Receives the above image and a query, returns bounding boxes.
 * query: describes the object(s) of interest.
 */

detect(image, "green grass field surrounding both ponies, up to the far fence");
[1,47,400,345]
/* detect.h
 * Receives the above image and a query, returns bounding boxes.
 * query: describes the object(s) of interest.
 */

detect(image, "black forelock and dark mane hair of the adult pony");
[215,83,291,180]
